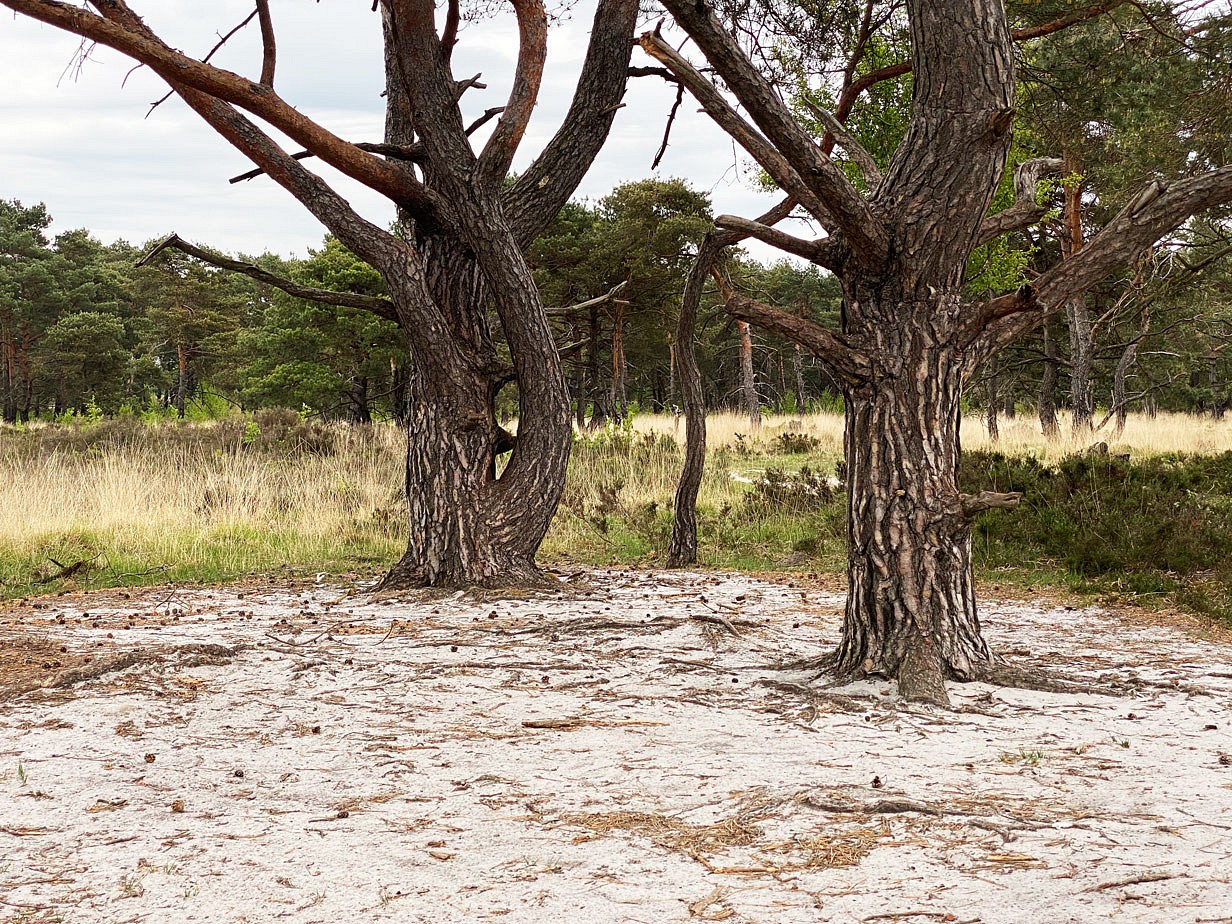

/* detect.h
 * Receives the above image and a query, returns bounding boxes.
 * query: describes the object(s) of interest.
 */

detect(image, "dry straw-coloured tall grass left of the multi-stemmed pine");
[0,421,405,595]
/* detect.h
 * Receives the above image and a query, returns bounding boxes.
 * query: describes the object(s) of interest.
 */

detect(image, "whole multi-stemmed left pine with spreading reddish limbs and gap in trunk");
[4,0,637,588]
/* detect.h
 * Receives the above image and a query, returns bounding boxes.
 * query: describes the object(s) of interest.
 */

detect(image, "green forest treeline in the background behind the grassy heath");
[0,174,1232,431]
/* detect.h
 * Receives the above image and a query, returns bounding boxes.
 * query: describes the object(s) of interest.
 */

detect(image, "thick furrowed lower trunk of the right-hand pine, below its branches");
[837,296,992,703]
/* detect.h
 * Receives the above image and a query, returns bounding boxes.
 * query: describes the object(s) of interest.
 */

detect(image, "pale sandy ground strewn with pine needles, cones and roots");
[0,570,1232,924]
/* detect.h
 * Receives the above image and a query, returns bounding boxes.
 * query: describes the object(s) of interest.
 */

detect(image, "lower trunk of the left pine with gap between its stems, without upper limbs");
[382,203,573,589]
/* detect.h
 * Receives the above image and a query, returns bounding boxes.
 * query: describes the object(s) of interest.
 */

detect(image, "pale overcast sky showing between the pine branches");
[0,0,788,259]
